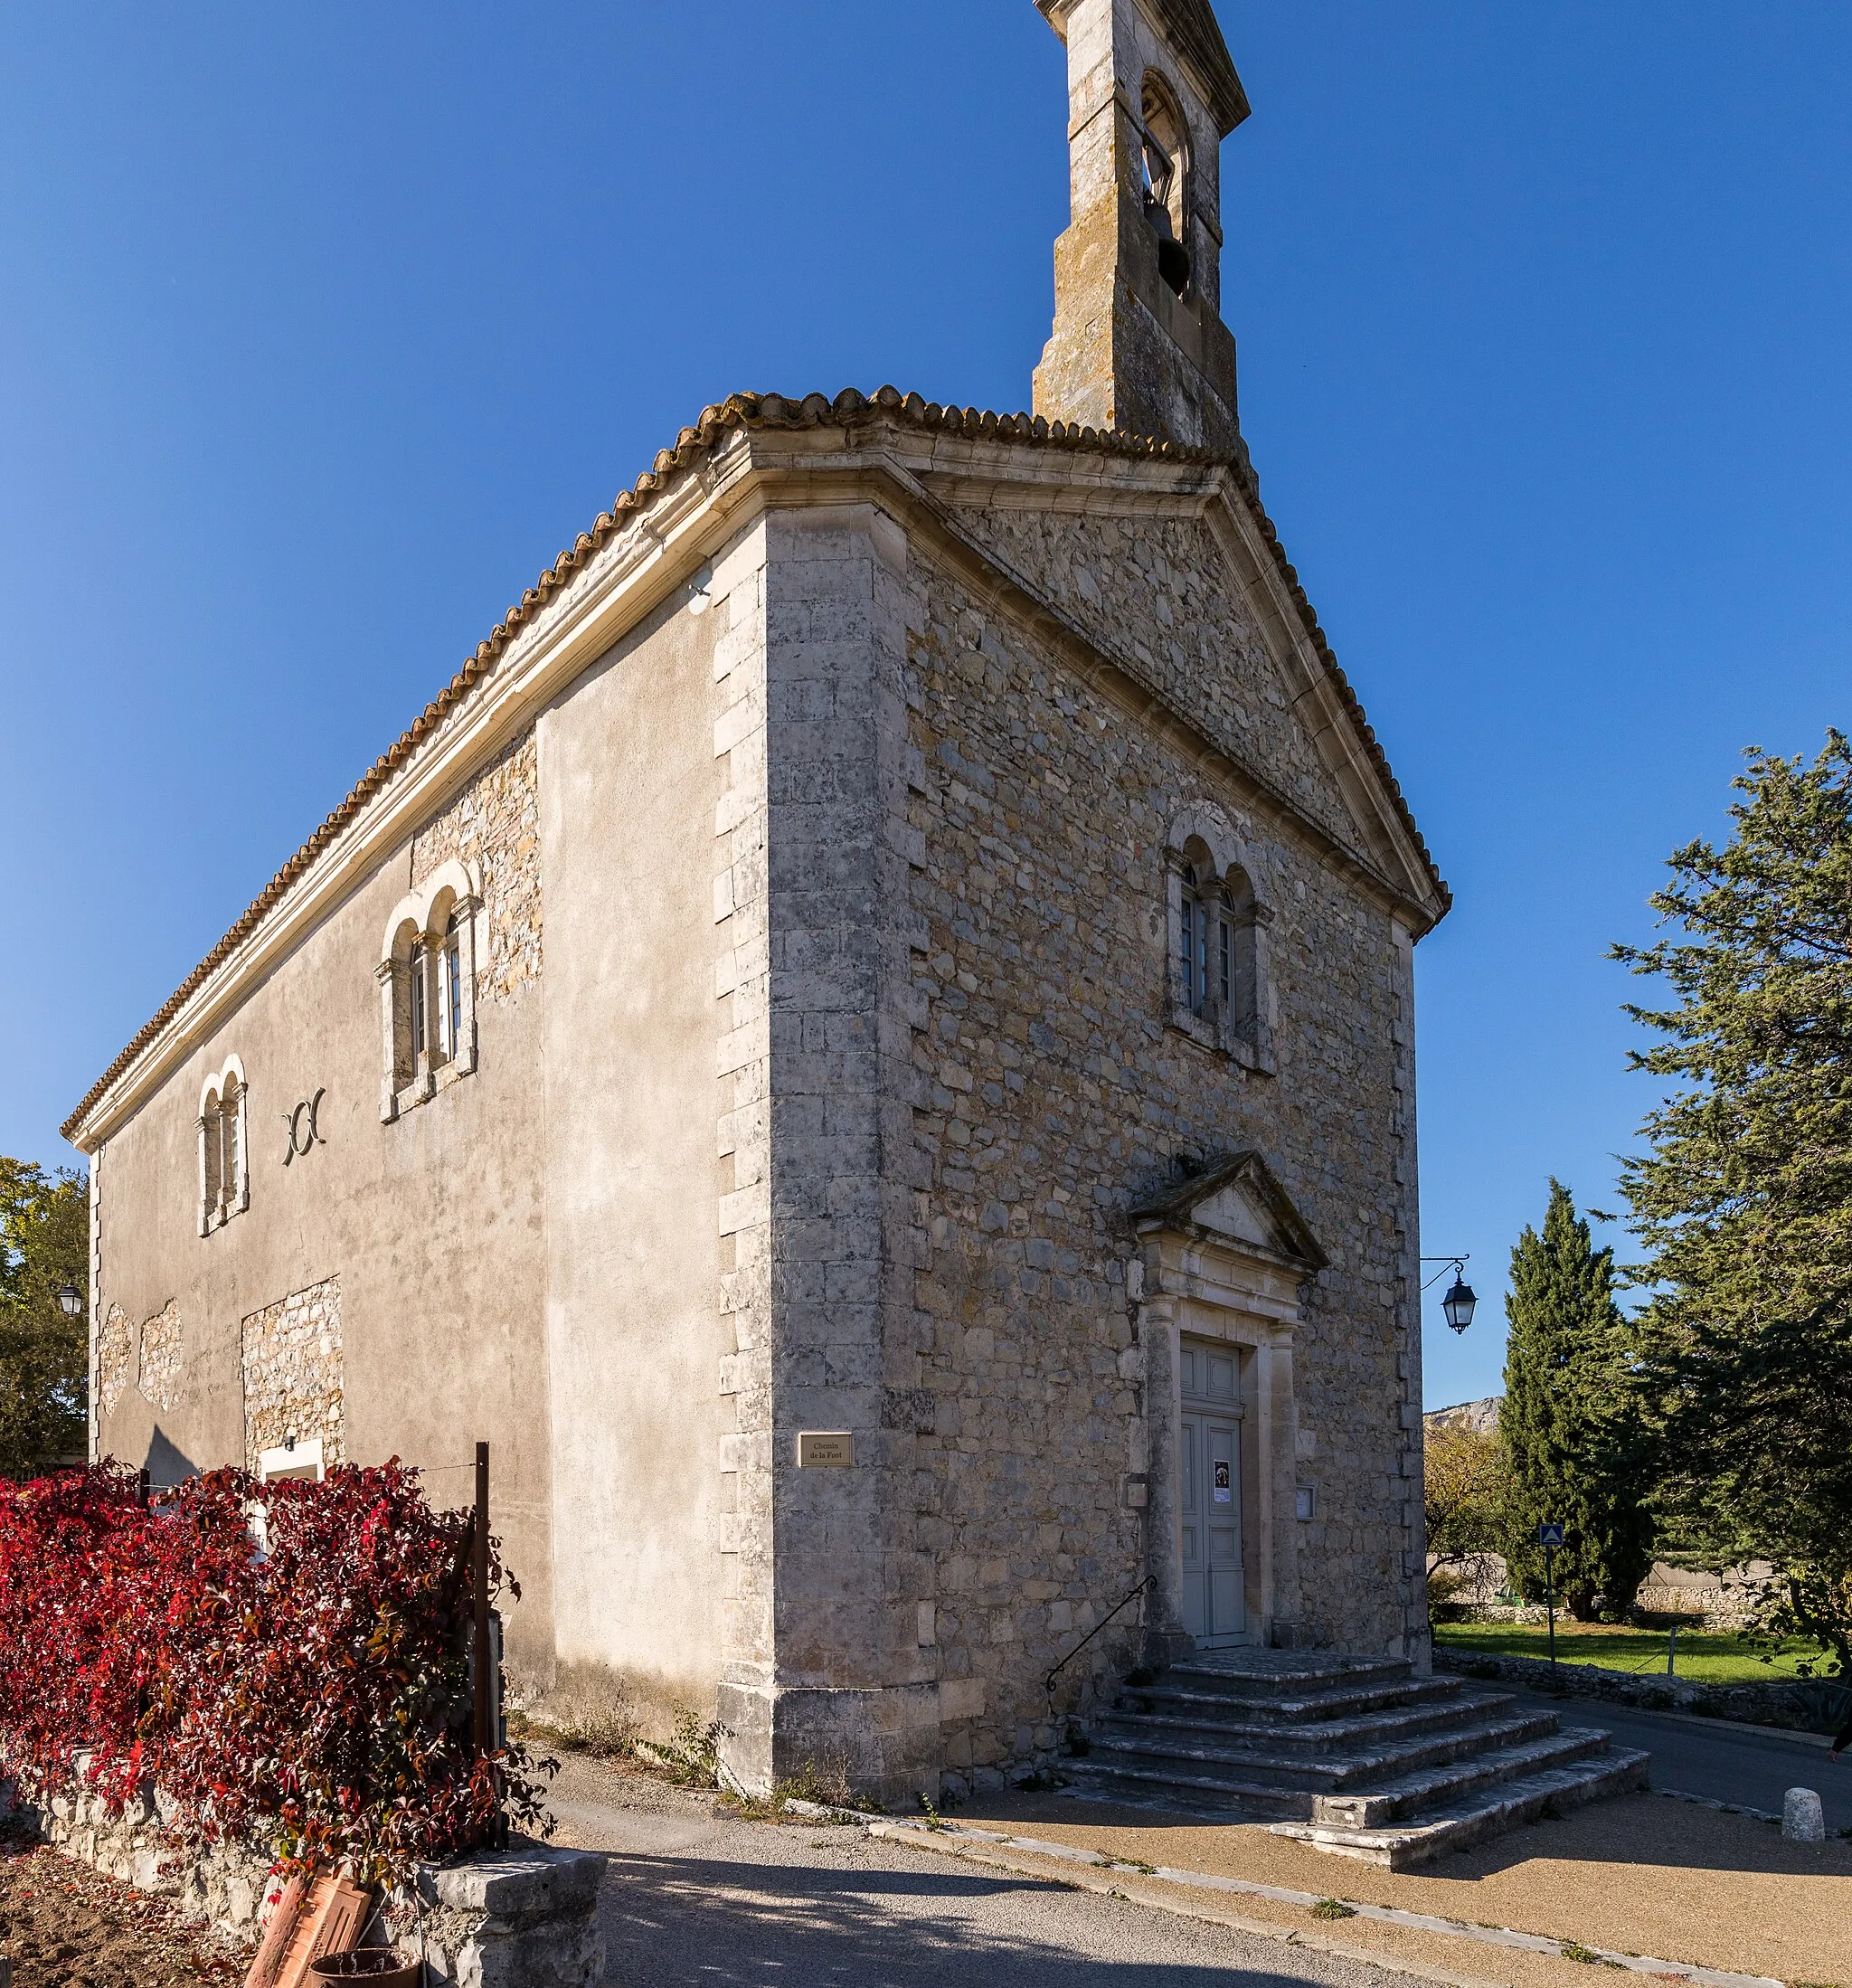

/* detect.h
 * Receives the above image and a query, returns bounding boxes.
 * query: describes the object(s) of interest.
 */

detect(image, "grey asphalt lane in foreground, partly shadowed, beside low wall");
[551,1759,1409,1988]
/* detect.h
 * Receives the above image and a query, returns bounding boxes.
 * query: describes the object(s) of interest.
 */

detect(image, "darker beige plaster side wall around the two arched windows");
[93,745,553,1670]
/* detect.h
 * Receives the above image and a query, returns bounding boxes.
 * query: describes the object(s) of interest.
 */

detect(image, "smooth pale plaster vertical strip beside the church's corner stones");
[539,592,732,1726]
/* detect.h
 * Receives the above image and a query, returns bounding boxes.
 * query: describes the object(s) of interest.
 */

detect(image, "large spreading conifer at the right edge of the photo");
[1616,732,1852,1676]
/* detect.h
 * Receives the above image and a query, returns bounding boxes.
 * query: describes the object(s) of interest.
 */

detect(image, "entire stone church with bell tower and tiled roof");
[66,0,1449,1799]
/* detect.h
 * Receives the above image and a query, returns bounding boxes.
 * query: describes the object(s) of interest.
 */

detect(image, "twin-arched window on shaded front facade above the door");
[1167,811,1276,1075]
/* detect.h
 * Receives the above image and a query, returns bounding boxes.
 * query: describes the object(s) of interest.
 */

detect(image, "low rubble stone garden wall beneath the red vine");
[0,1775,604,1988]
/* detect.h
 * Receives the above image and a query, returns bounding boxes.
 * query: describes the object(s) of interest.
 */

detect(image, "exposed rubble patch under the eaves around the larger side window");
[411,727,541,1002]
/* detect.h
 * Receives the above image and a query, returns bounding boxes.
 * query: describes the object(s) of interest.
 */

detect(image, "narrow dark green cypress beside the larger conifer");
[1498,1181,1653,1623]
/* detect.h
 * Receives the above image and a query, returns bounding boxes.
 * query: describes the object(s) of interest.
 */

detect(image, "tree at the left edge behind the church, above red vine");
[0,1155,90,1477]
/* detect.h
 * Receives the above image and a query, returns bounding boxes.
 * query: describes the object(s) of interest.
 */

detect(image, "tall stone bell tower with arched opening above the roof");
[1035,0,1248,451]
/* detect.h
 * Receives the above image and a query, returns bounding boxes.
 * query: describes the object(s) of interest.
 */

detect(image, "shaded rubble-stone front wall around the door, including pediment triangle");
[890,513,1425,1777]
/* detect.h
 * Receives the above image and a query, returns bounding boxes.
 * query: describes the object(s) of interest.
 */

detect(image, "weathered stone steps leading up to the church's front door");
[1063,1650,1645,1869]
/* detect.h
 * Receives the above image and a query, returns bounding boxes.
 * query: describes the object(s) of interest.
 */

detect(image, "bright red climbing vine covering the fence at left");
[0,1463,544,1885]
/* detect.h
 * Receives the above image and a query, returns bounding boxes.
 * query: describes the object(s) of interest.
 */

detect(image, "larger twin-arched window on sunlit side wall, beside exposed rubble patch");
[375,861,481,1123]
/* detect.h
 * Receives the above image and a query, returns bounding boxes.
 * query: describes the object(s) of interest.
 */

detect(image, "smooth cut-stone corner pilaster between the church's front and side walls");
[713,506,940,1789]
